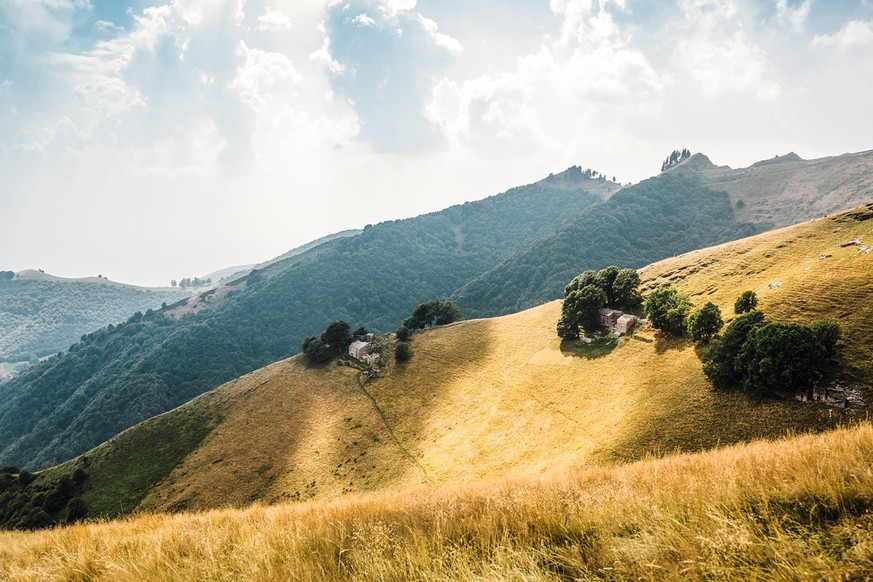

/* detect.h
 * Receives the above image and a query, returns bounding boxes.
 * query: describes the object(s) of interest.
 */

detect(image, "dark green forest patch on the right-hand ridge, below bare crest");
[454,173,758,317]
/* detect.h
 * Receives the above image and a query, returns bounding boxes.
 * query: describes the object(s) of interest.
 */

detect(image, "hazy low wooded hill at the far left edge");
[0,270,190,362]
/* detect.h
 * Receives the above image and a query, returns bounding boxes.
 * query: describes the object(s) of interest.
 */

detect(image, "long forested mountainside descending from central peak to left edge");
[0,168,617,469]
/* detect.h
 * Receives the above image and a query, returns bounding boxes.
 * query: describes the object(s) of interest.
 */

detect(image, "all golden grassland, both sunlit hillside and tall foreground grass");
[0,204,873,580]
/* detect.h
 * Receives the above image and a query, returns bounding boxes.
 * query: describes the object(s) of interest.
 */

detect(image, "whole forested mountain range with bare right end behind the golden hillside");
[0,152,873,468]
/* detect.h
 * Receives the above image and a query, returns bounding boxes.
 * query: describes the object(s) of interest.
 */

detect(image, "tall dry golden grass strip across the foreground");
[0,423,873,581]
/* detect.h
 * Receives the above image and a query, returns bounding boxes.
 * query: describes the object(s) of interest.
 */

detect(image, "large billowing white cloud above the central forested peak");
[429,0,664,157]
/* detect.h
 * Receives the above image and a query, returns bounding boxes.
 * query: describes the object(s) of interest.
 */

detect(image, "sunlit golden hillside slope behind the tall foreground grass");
[75,203,873,510]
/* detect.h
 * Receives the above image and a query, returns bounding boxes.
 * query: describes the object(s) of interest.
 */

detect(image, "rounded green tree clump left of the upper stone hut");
[558,265,642,339]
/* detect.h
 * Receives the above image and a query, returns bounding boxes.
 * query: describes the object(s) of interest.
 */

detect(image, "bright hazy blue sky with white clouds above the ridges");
[0,0,873,285]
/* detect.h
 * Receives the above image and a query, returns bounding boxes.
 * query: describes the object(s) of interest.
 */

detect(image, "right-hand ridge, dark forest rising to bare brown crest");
[455,151,873,316]
